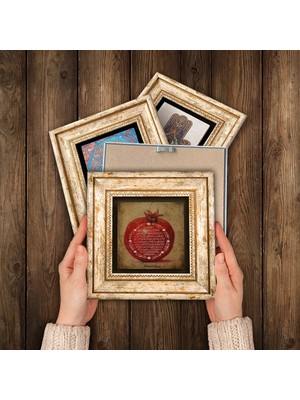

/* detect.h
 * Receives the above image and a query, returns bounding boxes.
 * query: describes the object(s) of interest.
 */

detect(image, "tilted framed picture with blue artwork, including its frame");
[50,96,168,232]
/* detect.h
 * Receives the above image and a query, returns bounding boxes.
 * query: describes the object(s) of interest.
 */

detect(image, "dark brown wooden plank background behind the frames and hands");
[0,51,300,349]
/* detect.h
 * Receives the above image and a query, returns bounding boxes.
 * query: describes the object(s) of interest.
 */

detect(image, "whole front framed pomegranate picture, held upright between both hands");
[87,172,215,300]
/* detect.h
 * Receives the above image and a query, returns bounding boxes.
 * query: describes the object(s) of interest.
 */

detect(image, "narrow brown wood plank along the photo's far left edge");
[0,51,26,349]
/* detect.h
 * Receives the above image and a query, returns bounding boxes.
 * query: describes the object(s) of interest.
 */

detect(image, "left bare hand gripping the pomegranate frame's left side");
[56,216,98,326]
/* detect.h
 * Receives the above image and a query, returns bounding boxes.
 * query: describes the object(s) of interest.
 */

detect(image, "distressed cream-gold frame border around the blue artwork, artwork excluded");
[49,96,168,233]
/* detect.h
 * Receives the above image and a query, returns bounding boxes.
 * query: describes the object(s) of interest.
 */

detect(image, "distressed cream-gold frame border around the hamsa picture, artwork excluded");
[140,73,246,147]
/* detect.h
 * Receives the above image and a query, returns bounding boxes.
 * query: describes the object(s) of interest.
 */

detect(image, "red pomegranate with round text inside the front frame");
[124,210,175,262]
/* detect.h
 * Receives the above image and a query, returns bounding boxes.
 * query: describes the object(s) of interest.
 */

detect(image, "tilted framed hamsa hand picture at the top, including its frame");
[140,73,246,147]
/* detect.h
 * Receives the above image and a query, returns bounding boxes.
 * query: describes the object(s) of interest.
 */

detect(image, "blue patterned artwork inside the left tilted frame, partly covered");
[81,128,139,171]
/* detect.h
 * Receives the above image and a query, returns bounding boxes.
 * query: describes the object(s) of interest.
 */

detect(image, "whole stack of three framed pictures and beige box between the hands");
[50,74,245,299]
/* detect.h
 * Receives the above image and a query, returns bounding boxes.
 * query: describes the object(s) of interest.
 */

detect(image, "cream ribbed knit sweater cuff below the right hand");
[207,317,254,350]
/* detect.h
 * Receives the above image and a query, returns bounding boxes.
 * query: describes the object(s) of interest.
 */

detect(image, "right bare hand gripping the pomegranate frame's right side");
[206,222,243,322]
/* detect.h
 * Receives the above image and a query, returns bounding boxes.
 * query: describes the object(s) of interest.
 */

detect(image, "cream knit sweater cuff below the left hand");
[41,323,90,350]
